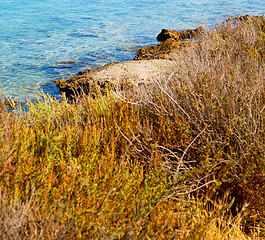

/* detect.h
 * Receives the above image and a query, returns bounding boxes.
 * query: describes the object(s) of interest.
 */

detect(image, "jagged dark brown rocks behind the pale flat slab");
[134,27,203,60]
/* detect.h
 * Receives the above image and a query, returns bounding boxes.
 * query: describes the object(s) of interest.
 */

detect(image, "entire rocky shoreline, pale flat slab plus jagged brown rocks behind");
[55,27,204,99]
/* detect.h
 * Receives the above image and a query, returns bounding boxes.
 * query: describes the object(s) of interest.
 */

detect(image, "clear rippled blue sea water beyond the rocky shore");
[0,0,265,102]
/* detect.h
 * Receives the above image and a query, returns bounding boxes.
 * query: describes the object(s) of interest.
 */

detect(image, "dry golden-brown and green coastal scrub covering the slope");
[0,17,265,240]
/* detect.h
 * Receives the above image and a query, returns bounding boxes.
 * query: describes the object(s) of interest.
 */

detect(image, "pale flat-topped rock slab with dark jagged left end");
[55,60,174,99]
